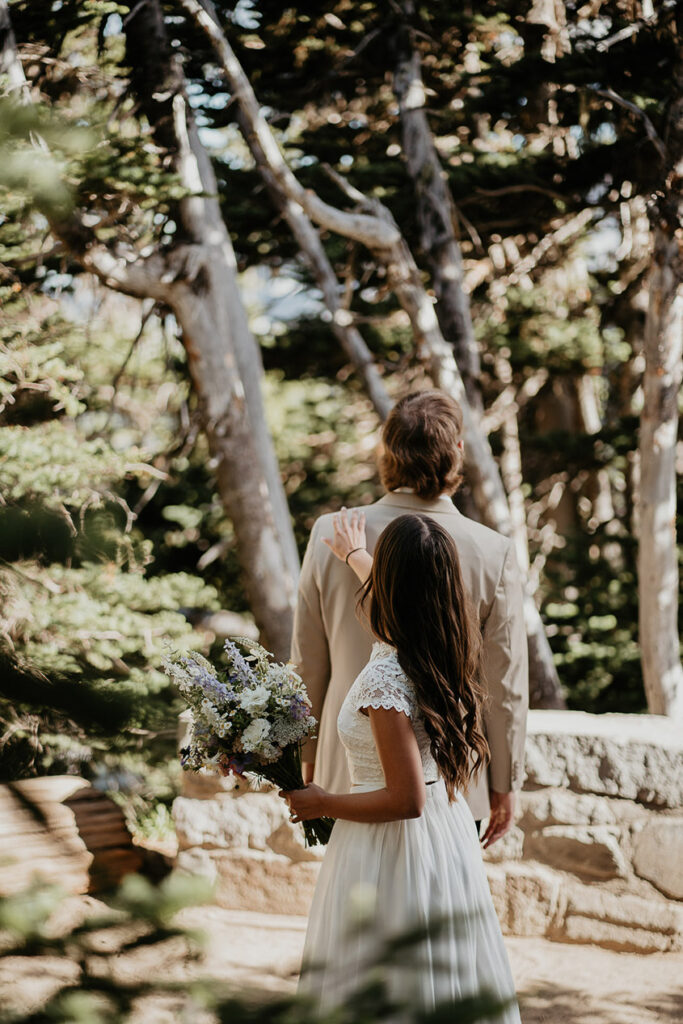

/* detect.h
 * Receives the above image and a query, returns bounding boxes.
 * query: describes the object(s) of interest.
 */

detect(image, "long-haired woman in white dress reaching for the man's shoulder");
[281,511,519,1024]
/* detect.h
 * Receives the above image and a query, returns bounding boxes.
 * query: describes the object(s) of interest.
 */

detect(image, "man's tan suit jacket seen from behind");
[292,492,528,818]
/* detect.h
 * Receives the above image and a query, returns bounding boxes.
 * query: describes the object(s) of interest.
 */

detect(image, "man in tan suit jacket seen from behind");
[292,391,528,846]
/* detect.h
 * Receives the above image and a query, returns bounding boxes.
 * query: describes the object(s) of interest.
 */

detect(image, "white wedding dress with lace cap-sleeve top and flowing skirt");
[300,643,520,1024]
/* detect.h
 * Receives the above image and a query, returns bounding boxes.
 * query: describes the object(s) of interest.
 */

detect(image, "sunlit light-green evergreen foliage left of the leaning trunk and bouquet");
[0,289,218,778]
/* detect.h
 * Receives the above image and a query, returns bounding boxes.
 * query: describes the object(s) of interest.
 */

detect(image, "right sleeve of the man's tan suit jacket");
[482,542,528,793]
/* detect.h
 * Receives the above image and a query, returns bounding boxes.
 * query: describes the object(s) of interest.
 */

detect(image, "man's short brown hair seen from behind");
[380,391,463,501]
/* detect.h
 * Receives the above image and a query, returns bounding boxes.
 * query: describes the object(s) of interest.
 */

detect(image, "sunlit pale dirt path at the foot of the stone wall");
[182,906,683,1024]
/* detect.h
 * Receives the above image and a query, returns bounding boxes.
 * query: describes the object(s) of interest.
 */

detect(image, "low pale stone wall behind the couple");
[173,711,683,952]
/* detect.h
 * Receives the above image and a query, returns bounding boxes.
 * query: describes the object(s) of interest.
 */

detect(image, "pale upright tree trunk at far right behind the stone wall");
[638,227,683,718]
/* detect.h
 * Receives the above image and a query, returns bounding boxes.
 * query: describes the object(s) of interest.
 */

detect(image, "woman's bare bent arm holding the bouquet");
[281,708,425,822]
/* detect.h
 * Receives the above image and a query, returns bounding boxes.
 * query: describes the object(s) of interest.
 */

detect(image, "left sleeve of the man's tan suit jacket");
[291,520,330,761]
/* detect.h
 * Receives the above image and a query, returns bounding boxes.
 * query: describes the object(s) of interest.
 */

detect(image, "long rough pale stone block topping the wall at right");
[526,711,683,807]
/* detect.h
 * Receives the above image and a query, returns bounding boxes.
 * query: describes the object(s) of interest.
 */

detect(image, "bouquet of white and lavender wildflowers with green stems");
[164,637,333,846]
